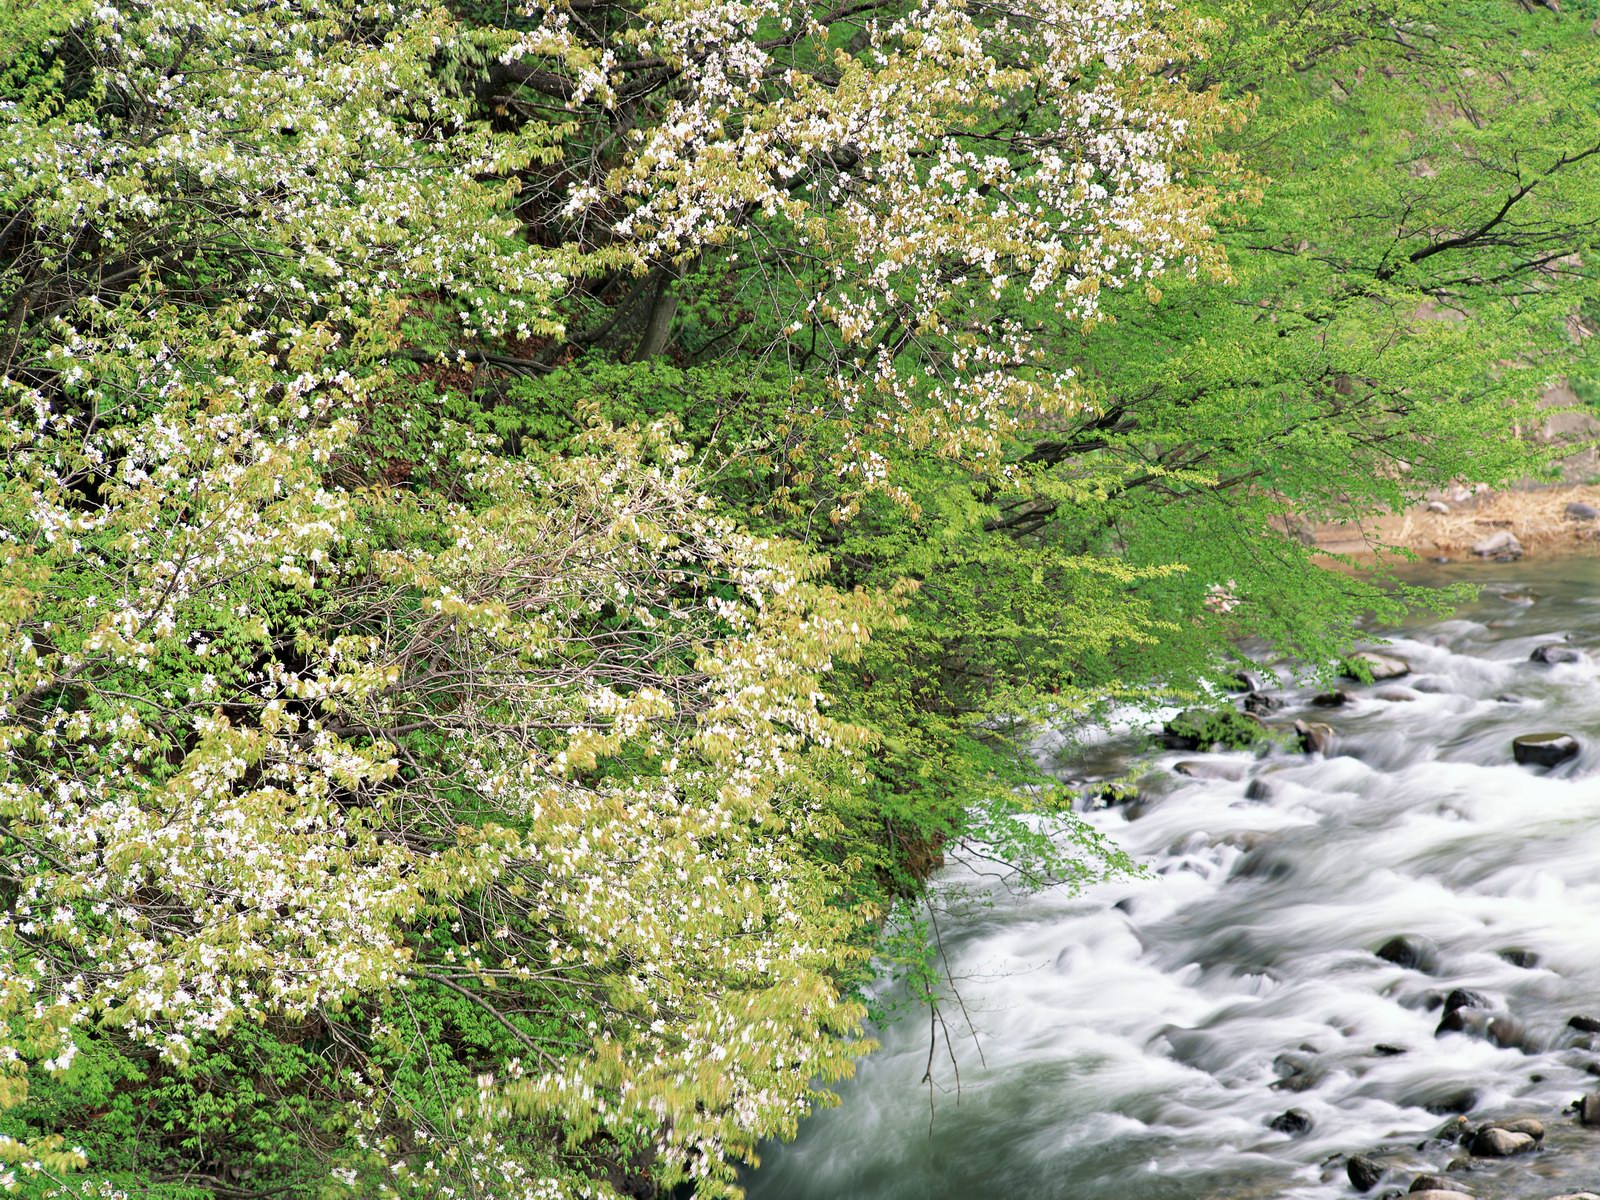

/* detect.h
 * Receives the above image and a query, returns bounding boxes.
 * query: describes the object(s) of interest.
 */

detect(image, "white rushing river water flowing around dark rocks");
[750,560,1600,1200]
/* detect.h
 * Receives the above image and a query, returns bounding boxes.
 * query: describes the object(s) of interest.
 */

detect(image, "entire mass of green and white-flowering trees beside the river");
[0,0,1600,1200]
